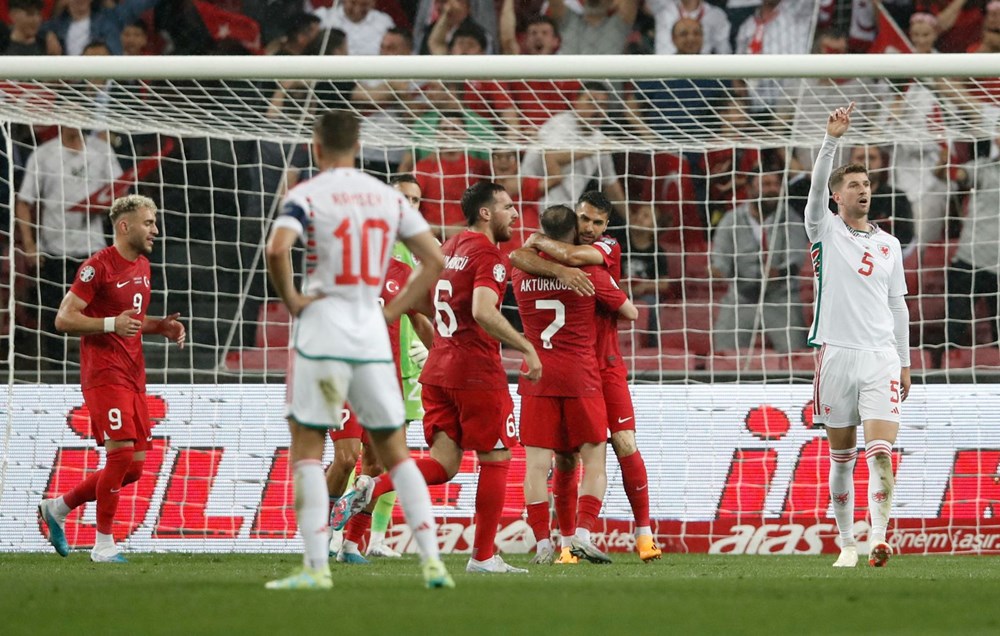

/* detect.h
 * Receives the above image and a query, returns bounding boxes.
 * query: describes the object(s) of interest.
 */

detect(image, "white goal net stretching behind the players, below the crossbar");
[0,55,1000,553]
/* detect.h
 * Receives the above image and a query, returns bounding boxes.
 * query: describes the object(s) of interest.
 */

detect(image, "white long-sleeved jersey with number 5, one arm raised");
[806,136,906,351]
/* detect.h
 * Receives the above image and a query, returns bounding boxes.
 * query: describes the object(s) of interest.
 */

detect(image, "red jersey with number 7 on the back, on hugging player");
[512,265,628,397]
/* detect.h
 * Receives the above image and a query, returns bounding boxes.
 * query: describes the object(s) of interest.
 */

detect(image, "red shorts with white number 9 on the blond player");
[83,385,153,451]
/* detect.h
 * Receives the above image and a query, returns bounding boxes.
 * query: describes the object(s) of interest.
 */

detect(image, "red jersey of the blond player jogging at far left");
[70,245,150,393]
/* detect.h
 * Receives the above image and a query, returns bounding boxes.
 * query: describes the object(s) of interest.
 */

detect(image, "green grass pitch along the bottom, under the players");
[0,551,1000,636]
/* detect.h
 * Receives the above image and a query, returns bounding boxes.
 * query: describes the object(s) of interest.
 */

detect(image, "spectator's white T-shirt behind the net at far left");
[18,135,122,257]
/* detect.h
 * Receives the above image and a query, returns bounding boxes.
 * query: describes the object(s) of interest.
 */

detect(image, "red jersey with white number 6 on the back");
[420,230,507,389]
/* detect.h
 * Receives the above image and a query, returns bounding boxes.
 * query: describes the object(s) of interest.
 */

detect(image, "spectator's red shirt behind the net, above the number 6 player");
[414,154,490,231]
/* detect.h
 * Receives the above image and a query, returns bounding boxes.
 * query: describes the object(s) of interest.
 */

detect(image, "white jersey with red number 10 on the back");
[274,168,430,362]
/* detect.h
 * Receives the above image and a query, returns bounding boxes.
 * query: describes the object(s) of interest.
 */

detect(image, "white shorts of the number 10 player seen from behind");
[285,351,406,430]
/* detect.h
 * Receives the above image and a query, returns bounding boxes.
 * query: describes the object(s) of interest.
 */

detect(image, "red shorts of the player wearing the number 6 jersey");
[421,384,517,453]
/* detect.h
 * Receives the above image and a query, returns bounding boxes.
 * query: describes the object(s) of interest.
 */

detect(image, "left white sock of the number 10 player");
[295,459,330,570]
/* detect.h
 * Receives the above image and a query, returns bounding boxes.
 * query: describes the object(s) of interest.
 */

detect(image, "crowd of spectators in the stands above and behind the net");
[0,0,1000,370]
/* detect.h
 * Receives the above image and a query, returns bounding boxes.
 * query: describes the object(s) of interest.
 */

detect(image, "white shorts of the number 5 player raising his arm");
[813,345,903,428]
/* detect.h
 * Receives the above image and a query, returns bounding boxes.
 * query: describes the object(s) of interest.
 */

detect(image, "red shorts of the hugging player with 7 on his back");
[521,395,608,451]
